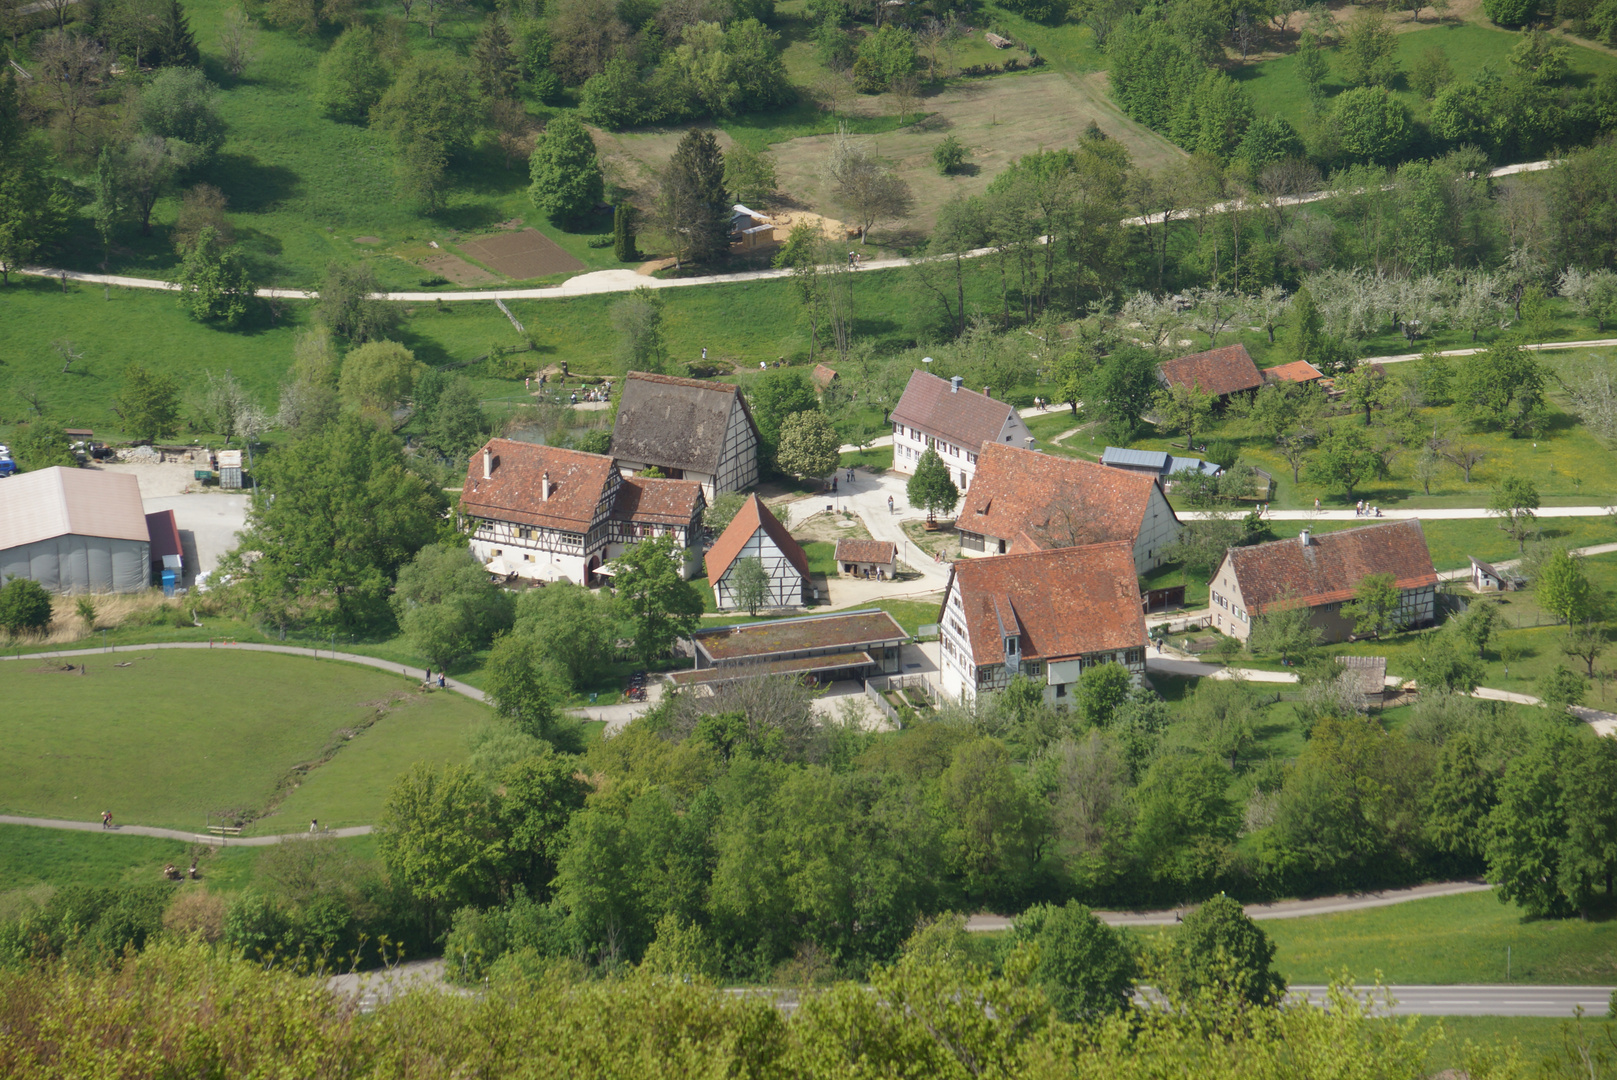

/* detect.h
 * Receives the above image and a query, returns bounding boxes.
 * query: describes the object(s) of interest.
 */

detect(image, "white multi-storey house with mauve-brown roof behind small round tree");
[888,372,1033,491]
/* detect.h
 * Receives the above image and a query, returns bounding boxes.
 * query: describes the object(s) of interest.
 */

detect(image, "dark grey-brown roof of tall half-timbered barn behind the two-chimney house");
[611,372,752,474]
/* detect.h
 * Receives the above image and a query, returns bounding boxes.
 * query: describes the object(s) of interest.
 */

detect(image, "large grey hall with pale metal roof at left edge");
[0,466,152,593]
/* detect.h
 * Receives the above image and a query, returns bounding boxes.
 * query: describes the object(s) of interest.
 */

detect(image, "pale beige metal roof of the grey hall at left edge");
[0,466,150,551]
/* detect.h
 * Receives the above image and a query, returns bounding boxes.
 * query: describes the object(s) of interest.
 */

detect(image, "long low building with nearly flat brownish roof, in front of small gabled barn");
[669,608,910,686]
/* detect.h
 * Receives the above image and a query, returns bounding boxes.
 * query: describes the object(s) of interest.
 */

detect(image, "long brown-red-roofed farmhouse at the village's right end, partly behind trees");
[1208,521,1438,642]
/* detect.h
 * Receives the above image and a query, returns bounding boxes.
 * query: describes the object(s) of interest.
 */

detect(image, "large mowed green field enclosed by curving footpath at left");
[0,650,488,833]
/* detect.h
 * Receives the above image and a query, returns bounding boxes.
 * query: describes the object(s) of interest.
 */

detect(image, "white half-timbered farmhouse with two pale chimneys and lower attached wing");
[461,438,707,585]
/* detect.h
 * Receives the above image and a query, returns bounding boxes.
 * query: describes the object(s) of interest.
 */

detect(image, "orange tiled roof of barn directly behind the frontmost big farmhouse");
[954,443,1177,550]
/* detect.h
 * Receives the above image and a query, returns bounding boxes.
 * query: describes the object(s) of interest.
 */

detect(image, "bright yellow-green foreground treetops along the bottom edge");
[9,931,1609,1080]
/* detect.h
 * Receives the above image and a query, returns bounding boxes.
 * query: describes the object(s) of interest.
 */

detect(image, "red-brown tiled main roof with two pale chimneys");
[461,438,616,532]
